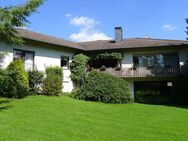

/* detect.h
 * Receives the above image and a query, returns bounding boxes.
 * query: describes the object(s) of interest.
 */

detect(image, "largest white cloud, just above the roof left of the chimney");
[70,16,111,42]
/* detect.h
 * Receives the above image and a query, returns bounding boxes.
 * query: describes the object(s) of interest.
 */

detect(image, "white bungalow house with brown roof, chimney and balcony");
[0,27,188,100]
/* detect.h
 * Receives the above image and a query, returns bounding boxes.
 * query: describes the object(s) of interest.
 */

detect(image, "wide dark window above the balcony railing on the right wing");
[133,54,179,68]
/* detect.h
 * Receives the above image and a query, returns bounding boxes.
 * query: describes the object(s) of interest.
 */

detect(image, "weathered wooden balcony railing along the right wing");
[97,67,180,77]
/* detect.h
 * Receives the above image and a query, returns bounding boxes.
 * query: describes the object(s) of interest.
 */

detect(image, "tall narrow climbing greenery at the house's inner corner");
[70,54,89,87]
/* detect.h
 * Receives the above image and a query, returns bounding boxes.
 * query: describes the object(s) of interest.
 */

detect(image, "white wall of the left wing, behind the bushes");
[0,42,74,92]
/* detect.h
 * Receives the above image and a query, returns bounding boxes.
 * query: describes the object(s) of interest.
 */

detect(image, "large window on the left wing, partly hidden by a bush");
[13,49,34,70]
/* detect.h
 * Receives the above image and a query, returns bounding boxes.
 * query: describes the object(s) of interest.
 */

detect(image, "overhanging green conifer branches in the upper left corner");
[0,0,43,45]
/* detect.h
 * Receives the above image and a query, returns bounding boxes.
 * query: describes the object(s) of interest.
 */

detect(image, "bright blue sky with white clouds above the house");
[0,0,188,42]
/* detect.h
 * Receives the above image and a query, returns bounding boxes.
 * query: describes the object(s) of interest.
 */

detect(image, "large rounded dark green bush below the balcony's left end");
[76,70,132,103]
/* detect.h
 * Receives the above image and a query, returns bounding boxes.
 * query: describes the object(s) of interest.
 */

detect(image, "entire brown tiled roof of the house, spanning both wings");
[18,29,188,51]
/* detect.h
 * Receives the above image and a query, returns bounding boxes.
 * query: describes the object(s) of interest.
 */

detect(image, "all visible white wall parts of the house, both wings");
[0,39,188,97]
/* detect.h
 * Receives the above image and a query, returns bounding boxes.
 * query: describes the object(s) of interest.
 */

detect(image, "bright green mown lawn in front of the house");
[0,96,188,141]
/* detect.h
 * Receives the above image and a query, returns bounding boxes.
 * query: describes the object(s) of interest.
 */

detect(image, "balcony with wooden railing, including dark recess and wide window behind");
[91,53,185,77]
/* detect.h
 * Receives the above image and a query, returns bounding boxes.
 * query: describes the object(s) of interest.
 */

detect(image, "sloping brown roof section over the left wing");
[17,28,84,50]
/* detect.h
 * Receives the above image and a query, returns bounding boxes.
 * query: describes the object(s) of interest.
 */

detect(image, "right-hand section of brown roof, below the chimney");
[79,38,188,51]
